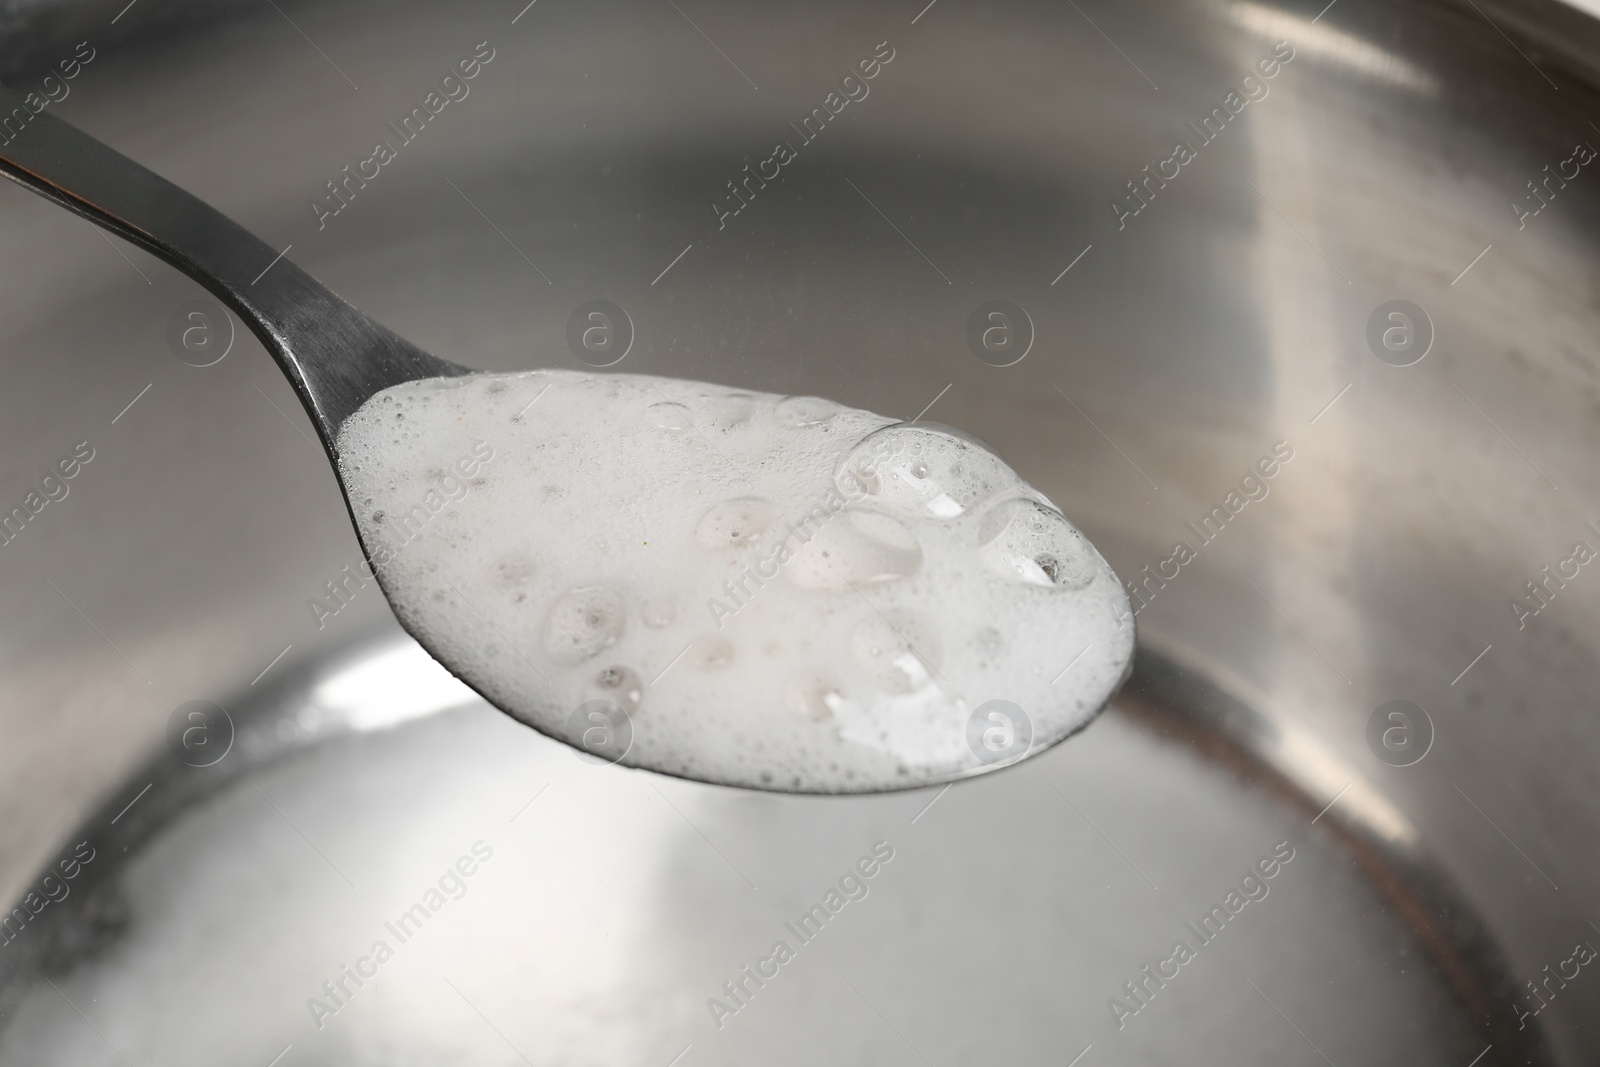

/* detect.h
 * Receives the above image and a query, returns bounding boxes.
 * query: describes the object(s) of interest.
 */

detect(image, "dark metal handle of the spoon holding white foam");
[0,86,469,456]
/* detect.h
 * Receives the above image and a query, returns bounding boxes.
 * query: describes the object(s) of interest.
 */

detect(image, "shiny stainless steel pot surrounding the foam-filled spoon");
[0,0,1600,1067]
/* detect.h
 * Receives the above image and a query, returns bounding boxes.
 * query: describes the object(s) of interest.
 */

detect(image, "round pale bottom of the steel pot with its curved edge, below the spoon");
[0,640,1549,1065]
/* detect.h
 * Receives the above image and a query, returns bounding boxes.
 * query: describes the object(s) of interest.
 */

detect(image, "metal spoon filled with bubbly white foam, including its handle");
[0,88,1134,792]
